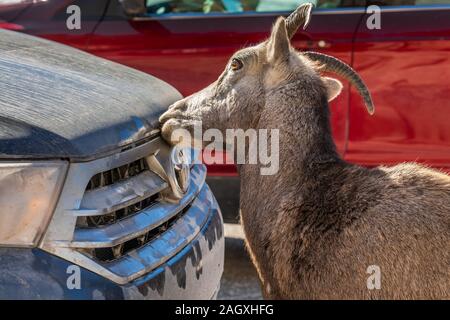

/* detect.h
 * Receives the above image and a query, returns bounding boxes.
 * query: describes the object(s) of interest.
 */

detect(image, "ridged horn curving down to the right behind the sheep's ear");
[302,51,375,114]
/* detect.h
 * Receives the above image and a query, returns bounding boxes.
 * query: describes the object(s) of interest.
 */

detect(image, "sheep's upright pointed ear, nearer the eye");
[267,17,290,63]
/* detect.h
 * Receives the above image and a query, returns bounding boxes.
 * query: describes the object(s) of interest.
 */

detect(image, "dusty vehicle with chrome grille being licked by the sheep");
[0,31,224,299]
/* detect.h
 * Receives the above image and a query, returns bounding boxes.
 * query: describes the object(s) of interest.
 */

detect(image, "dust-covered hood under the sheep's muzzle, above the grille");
[0,30,181,159]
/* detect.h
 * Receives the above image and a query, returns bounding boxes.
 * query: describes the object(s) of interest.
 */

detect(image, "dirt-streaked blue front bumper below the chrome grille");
[0,185,224,299]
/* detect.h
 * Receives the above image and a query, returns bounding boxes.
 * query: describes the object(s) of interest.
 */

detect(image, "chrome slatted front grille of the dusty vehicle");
[43,138,210,283]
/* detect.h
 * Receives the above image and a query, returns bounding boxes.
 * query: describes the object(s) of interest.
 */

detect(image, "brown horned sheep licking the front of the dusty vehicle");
[160,4,450,299]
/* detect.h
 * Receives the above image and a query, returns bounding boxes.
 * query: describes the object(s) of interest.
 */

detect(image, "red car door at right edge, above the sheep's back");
[346,0,450,170]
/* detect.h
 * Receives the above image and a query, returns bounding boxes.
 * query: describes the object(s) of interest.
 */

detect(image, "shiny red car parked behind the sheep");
[0,0,450,217]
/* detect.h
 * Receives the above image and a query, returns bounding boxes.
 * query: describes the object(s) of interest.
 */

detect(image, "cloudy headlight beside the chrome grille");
[0,161,67,247]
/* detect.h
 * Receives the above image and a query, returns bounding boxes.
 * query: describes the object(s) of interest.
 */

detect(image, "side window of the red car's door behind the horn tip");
[146,0,365,15]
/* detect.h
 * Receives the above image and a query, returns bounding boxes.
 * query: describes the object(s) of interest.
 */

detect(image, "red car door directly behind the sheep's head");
[88,0,363,158]
